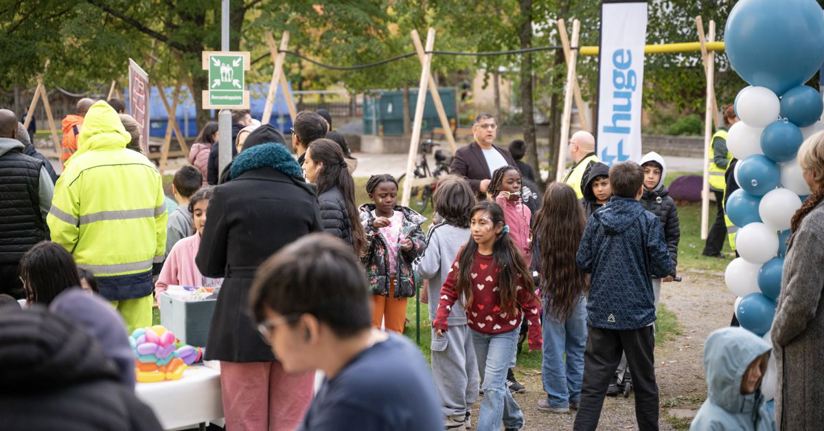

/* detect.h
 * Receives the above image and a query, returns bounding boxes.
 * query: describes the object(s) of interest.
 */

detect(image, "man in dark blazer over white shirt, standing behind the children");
[449,114,518,194]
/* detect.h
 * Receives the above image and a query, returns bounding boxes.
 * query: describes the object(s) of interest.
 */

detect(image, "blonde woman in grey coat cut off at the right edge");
[772,133,824,430]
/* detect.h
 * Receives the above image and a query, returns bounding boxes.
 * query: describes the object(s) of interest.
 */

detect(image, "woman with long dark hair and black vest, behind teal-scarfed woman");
[303,138,365,256]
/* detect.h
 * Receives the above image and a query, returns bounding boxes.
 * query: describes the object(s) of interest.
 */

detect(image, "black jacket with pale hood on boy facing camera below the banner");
[641,151,681,275]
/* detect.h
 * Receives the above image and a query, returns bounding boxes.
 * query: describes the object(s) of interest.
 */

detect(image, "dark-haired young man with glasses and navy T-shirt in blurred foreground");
[250,234,444,431]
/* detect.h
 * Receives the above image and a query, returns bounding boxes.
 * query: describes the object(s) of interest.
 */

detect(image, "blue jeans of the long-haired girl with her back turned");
[541,296,587,408]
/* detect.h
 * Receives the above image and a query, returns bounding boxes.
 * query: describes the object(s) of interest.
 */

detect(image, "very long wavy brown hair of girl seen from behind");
[533,182,588,321]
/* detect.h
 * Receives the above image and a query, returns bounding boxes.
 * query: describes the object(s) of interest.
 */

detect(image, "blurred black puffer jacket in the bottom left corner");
[0,306,161,431]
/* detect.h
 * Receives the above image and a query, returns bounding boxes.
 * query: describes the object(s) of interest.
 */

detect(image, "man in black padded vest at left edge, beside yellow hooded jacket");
[0,109,54,299]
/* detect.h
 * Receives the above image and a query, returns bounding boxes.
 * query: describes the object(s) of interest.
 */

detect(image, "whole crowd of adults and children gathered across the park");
[0,99,824,431]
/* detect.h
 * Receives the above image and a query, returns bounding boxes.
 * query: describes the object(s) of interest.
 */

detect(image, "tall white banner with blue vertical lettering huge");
[596,2,647,165]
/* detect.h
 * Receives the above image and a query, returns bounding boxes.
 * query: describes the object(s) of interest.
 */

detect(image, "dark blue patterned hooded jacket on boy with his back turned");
[575,196,673,330]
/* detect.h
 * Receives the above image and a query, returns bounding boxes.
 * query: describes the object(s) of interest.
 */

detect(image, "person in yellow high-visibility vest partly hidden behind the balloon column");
[703,105,738,257]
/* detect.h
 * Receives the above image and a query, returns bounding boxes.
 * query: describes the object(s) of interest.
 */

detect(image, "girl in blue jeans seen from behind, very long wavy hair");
[534,182,588,413]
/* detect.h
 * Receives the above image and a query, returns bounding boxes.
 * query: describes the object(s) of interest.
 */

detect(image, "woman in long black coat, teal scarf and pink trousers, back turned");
[195,125,321,430]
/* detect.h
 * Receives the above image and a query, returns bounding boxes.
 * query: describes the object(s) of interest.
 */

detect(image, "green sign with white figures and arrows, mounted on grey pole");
[203,51,249,109]
